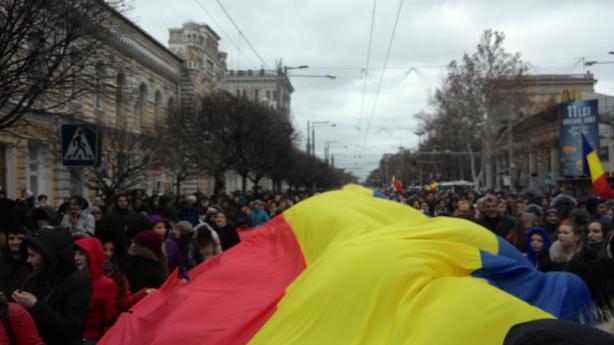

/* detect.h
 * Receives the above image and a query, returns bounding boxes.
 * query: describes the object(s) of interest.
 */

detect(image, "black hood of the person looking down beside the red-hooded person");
[24,227,76,277]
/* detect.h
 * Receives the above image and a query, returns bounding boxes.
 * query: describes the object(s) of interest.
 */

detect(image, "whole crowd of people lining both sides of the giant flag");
[0,190,614,344]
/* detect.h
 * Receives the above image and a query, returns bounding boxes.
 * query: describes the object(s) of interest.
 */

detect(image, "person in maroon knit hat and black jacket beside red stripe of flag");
[126,230,168,293]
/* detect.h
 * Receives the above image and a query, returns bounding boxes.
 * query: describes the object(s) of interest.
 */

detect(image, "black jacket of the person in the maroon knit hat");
[126,245,166,294]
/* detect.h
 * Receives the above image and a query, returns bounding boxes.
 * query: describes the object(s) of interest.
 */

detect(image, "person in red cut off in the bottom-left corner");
[0,292,45,345]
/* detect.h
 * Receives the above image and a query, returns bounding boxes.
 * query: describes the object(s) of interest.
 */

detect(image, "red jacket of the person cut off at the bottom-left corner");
[0,303,45,345]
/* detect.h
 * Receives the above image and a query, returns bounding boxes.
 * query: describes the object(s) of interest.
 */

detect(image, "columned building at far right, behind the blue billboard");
[495,74,614,191]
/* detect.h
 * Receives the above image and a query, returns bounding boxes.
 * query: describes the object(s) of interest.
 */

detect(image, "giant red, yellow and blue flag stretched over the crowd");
[100,186,590,345]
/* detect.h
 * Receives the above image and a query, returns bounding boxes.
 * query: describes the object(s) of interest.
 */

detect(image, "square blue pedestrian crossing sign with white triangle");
[61,124,98,166]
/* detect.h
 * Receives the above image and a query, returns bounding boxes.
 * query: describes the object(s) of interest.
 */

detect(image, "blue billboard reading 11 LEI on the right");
[559,100,599,177]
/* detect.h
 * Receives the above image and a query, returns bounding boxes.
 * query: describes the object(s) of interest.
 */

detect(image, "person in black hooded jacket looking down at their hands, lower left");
[12,227,92,345]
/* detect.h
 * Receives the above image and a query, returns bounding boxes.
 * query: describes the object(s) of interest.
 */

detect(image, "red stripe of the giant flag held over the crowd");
[99,216,306,345]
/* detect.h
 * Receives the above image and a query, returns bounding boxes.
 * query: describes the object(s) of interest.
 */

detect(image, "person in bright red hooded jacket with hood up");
[75,237,119,344]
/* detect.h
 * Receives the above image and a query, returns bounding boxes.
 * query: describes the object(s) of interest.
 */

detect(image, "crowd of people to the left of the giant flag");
[0,190,307,345]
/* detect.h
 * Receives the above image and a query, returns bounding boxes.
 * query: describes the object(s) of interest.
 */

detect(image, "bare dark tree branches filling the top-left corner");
[0,0,126,130]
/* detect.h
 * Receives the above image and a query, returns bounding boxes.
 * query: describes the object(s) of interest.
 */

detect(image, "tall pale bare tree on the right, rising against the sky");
[422,30,529,188]
